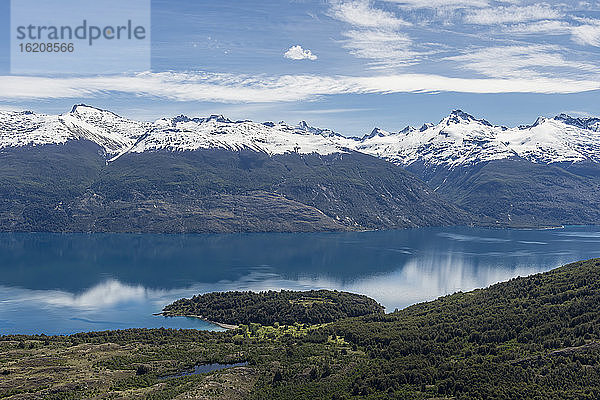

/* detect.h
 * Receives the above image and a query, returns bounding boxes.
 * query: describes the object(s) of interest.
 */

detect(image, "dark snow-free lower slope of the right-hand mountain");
[408,159,600,226]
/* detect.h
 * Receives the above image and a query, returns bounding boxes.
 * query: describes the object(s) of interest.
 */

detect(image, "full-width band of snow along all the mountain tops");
[0,105,600,169]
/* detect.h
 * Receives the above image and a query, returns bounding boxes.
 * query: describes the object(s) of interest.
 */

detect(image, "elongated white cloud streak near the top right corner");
[465,4,561,25]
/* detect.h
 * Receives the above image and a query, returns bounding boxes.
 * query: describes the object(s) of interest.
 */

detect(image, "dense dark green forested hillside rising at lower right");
[318,259,600,399]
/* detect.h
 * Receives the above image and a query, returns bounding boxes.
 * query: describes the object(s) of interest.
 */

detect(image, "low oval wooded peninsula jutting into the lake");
[163,290,384,325]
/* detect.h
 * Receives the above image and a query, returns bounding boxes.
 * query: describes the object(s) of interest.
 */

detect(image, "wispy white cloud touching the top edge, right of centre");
[331,0,410,29]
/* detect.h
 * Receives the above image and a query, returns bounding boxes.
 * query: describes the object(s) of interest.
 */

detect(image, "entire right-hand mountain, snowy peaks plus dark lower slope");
[354,111,600,227]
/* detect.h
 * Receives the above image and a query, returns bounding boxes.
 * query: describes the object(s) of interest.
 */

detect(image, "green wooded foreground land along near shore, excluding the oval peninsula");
[0,259,600,400]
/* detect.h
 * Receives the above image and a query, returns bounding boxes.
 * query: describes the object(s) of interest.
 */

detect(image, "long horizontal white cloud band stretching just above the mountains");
[0,70,600,103]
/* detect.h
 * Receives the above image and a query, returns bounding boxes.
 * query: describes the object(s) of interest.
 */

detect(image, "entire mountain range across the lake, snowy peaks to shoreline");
[0,105,600,232]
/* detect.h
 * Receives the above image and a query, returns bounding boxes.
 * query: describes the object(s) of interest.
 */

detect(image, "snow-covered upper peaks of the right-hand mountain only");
[355,110,600,168]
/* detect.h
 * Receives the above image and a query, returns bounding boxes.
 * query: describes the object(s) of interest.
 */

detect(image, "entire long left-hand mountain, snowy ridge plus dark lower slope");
[0,106,471,232]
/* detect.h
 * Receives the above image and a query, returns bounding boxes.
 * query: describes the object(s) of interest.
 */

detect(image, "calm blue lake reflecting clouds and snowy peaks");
[0,227,600,334]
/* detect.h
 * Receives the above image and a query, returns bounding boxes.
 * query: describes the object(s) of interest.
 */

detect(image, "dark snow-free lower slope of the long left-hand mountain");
[0,144,472,233]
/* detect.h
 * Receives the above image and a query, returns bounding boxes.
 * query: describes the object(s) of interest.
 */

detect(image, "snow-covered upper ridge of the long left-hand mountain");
[0,105,353,160]
